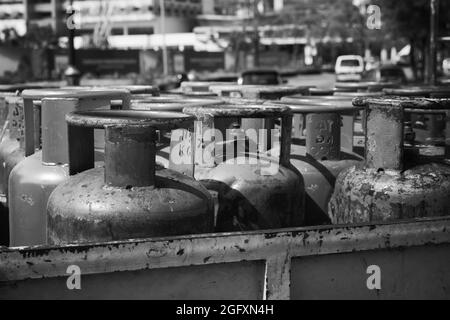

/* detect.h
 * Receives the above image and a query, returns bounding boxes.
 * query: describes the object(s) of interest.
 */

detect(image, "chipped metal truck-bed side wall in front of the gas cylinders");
[0,217,450,299]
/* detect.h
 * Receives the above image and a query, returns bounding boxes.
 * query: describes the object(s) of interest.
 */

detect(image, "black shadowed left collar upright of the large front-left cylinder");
[67,124,94,175]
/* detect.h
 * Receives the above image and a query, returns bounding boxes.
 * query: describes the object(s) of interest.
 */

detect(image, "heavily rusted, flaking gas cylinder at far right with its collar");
[329,97,450,223]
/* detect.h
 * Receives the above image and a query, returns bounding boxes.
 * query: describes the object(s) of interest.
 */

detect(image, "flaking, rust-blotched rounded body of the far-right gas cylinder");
[329,164,450,223]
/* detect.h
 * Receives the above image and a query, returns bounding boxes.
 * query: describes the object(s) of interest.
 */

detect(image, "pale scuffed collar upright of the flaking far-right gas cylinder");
[366,103,404,170]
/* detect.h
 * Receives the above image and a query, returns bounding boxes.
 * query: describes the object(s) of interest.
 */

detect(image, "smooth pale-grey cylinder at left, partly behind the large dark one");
[8,92,120,246]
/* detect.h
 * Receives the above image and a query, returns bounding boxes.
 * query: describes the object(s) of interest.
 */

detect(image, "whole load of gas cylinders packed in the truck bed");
[0,82,450,246]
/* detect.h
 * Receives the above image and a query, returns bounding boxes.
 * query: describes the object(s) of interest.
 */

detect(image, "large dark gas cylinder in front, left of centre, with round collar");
[47,110,214,244]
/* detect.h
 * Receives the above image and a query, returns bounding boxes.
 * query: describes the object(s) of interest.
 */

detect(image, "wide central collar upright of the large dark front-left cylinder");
[105,125,156,188]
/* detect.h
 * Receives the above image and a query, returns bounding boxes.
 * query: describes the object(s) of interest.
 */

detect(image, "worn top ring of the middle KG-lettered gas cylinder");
[183,104,292,118]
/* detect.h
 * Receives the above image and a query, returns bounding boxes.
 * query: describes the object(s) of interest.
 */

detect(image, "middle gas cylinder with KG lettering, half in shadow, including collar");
[183,105,304,232]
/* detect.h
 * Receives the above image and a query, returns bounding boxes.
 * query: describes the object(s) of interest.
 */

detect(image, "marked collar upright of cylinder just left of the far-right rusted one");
[306,113,341,160]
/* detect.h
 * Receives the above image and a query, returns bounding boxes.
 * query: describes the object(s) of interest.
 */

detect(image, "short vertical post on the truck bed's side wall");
[263,252,291,300]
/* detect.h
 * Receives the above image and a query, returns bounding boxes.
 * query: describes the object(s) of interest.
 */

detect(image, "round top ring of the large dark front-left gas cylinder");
[66,110,194,130]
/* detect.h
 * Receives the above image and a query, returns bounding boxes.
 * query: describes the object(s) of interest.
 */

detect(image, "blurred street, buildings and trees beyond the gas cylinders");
[0,0,450,89]
